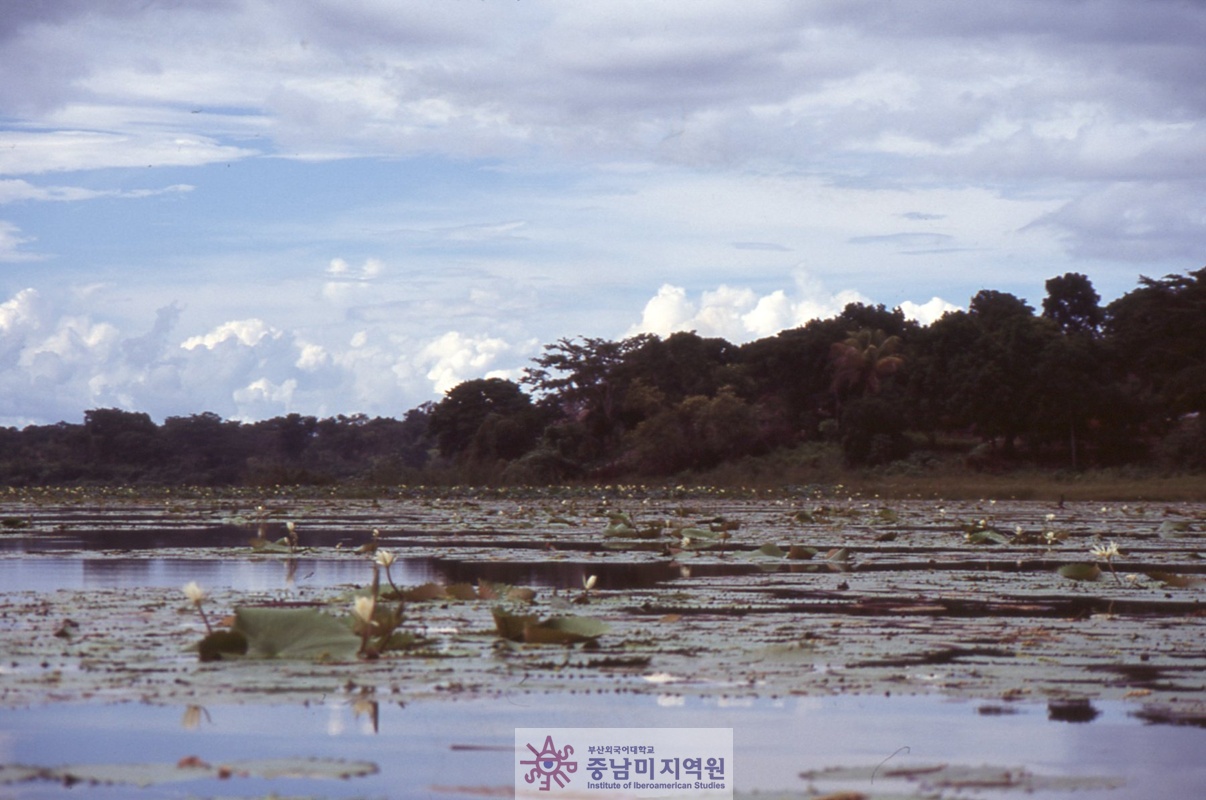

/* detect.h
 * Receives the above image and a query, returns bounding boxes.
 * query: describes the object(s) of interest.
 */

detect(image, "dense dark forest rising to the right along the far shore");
[0,268,1206,486]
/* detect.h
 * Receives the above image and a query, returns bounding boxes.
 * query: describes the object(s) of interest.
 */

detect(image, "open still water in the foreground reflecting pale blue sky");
[0,691,1206,800]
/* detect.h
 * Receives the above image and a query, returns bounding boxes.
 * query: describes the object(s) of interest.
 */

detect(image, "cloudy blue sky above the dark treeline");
[0,0,1206,427]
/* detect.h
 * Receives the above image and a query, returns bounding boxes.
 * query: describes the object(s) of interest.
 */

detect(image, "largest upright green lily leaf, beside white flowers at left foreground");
[230,607,361,661]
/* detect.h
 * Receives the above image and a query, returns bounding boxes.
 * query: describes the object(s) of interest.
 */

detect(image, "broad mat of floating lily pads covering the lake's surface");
[0,492,1206,706]
